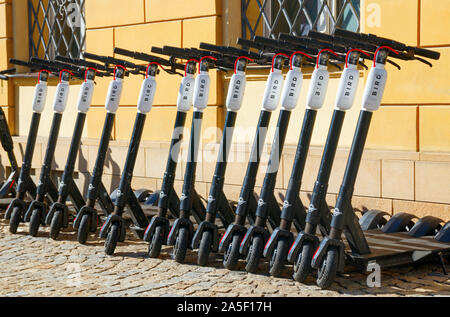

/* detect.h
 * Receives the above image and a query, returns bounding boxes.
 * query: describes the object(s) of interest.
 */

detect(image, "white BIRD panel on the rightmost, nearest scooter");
[362,64,387,111]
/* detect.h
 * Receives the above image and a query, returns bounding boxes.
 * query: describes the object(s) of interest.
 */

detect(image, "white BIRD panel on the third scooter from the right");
[306,65,330,110]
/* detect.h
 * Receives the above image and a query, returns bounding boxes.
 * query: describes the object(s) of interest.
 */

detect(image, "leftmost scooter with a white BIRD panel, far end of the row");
[5,59,58,233]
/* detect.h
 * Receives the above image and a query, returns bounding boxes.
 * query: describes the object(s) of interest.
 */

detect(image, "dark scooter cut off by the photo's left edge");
[0,68,19,198]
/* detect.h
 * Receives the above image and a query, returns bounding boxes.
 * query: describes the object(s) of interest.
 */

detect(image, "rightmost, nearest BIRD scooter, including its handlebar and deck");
[311,30,450,288]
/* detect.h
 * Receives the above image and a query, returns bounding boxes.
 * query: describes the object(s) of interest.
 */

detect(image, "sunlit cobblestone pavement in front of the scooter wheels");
[0,220,450,297]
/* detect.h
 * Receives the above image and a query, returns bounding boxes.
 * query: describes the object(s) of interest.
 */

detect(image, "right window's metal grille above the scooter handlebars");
[241,0,360,39]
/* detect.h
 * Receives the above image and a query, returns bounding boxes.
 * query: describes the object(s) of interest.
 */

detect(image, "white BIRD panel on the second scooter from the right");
[335,64,359,111]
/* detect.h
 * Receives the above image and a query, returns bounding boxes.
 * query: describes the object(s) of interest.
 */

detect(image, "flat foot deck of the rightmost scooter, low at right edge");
[344,229,450,267]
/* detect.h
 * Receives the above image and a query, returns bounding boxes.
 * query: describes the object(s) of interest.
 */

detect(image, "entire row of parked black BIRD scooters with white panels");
[0,29,450,288]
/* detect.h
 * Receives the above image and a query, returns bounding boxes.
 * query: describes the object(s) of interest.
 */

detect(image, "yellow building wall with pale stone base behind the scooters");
[0,0,450,220]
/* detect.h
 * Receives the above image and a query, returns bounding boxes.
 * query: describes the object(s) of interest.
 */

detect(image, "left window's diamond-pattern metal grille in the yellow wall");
[28,0,86,59]
